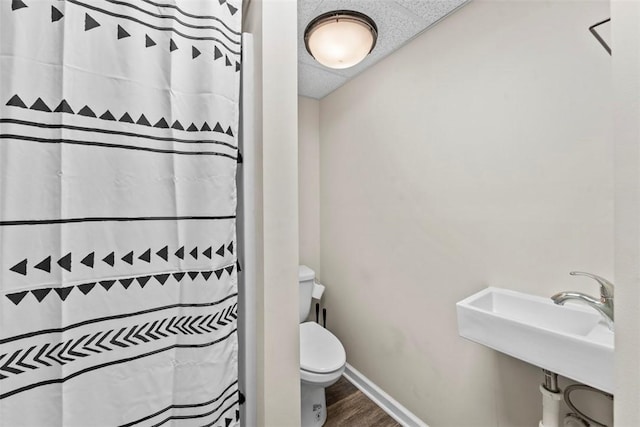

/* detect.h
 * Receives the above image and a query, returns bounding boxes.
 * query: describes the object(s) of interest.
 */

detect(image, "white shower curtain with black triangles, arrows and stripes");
[0,0,242,427]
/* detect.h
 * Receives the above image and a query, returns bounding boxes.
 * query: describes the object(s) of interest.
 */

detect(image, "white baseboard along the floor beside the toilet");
[342,363,429,427]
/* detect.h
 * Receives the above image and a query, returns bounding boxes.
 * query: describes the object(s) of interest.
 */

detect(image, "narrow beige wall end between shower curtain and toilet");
[244,0,300,427]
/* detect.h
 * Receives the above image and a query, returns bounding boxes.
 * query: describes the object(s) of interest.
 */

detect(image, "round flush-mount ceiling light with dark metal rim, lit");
[304,10,378,68]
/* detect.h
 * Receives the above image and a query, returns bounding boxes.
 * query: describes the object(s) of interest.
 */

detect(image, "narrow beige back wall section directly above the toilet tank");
[298,97,320,275]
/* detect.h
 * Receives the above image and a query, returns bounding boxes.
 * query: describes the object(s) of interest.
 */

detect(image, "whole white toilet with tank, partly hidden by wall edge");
[298,265,347,427]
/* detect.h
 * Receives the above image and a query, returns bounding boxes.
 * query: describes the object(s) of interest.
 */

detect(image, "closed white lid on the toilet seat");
[300,322,347,374]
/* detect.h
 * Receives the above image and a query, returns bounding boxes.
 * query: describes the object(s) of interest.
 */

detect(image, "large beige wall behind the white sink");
[320,0,614,427]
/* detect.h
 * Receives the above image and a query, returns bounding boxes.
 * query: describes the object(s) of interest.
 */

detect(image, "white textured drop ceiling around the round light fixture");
[298,0,469,99]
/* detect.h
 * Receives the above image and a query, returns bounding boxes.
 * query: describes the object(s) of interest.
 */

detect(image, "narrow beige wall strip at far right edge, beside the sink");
[611,0,640,426]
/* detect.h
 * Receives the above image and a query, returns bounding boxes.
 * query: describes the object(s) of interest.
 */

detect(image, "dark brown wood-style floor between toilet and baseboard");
[324,377,400,427]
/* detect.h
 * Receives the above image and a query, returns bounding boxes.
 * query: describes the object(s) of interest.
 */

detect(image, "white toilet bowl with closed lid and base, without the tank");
[300,322,347,427]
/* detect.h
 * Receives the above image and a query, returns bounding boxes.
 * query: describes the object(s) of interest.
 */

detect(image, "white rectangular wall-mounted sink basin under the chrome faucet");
[456,287,614,394]
